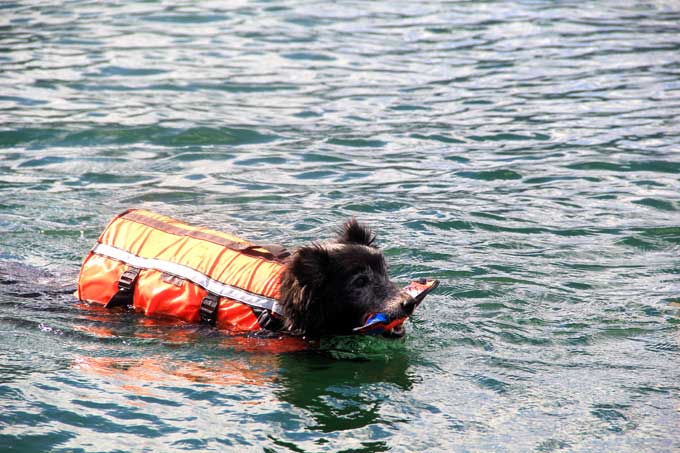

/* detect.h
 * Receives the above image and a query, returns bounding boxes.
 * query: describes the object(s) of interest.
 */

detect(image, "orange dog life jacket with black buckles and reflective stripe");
[78,209,290,331]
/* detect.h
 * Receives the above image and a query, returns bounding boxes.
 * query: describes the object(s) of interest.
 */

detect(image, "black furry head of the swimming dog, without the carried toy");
[281,219,416,337]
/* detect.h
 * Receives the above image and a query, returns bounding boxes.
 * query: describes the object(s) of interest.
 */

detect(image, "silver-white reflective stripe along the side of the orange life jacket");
[92,243,283,316]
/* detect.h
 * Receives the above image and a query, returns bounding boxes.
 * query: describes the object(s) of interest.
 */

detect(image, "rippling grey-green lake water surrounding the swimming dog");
[0,0,680,452]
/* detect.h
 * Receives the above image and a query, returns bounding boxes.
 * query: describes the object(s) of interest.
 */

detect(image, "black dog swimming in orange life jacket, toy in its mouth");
[78,209,437,338]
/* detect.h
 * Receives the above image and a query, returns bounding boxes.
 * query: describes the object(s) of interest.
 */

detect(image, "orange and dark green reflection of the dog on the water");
[74,298,413,433]
